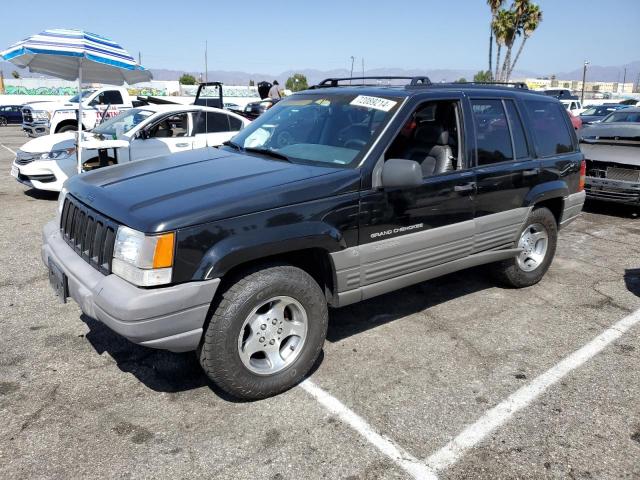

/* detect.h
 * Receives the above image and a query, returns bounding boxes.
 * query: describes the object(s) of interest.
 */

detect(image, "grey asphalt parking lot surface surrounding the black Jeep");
[0,127,640,479]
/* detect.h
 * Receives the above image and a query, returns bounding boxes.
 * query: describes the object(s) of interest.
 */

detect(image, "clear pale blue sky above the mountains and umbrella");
[0,0,640,73]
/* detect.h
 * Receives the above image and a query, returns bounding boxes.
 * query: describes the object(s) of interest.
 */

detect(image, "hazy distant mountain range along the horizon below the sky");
[0,61,640,85]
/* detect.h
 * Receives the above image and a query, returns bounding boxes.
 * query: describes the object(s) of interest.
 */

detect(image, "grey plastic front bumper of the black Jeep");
[42,221,220,352]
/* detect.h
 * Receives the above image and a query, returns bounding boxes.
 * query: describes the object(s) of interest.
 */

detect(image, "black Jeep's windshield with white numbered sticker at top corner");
[231,92,402,167]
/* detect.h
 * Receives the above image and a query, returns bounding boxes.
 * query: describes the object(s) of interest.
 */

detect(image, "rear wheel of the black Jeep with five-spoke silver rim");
[493,207,558,288]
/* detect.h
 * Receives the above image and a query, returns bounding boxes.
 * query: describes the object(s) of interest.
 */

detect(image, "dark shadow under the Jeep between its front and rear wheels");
[327,268,496,342]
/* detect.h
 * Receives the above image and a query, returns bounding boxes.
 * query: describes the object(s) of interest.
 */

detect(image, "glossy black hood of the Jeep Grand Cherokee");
[65,149,360,233]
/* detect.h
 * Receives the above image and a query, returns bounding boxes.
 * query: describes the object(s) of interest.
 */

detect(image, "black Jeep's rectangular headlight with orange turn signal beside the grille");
[111,226,175,287]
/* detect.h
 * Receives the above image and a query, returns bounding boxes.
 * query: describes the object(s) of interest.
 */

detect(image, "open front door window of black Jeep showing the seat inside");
[385,100,464,177]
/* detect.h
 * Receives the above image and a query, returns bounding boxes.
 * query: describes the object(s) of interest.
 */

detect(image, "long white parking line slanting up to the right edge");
[426,310,640,471]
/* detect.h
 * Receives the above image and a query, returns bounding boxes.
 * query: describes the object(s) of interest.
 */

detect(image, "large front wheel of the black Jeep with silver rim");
[199,266,329,400]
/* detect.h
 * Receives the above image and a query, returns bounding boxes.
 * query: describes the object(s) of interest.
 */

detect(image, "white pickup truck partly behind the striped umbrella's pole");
[22,87,133,137]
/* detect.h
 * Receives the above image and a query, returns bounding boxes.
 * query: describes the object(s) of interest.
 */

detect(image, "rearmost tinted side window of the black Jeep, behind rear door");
[524,100,574,157]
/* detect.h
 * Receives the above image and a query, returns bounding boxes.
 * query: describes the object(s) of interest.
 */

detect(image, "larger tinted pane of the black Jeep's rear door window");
[471,100,513,165]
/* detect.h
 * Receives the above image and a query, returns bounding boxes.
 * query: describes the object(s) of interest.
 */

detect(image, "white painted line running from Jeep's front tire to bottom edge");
[300,380,438,480]
